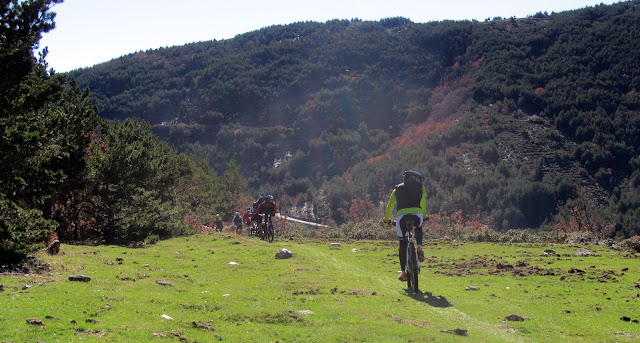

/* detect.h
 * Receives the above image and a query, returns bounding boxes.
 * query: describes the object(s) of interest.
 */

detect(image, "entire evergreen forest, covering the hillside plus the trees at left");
[0,0,640,261]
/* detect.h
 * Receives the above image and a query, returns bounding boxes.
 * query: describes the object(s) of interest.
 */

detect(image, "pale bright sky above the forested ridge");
[40,0,619,72]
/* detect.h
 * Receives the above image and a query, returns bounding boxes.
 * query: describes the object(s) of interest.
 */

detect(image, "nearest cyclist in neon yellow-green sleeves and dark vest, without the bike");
[384,170,427,281]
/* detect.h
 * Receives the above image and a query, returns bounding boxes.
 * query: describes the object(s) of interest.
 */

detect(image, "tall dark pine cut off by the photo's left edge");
[0,0,97,264]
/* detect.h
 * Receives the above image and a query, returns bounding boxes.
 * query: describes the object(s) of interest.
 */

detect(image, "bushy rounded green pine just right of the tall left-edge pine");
[83,119,191,243]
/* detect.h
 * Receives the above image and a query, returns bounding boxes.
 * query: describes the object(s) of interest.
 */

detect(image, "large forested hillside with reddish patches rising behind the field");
[69,1,640,237]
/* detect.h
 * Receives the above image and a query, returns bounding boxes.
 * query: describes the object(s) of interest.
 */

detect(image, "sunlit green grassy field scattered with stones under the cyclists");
[0,233,640,342]
